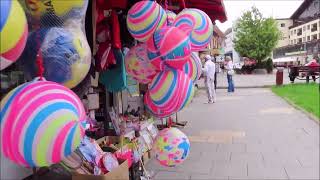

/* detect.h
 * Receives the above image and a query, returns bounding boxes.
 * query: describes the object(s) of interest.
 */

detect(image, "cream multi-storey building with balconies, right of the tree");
[273,0,320,64]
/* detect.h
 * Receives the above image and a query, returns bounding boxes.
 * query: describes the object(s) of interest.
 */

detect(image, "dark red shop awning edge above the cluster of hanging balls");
[168,0,227,23]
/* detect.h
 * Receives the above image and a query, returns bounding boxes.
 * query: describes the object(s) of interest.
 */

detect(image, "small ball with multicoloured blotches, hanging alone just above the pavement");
[154,127,190,167]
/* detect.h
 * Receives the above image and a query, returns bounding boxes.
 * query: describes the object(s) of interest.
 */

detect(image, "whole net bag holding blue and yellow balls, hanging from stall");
[19,0,91,88]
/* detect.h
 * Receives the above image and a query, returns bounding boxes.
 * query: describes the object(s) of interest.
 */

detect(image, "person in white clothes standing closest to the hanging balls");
[202,55,216,104]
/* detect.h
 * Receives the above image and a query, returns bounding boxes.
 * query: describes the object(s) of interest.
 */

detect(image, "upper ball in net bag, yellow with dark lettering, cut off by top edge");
[20,0,88,27]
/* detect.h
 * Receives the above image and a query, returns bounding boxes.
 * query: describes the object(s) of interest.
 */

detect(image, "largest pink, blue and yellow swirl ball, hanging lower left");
[0,80,86,167]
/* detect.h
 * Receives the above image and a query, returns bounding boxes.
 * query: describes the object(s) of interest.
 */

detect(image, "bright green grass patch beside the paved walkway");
[271,83,320,121]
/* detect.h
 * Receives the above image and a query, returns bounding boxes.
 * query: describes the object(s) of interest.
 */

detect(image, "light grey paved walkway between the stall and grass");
[147,88,320,180]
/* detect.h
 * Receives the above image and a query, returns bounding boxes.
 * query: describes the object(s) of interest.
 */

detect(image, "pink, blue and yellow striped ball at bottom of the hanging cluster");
[144,69,194,118]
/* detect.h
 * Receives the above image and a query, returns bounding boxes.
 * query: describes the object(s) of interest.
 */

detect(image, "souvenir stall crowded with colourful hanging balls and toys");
[0,0,225,180]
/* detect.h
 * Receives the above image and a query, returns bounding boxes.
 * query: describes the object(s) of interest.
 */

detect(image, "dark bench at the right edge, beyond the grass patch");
[289,66,320,83]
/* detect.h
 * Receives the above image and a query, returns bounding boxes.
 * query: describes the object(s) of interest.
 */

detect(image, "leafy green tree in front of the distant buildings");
[234,7,281,66]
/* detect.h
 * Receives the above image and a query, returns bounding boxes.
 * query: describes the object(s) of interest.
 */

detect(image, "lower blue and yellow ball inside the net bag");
[19,28,91,88]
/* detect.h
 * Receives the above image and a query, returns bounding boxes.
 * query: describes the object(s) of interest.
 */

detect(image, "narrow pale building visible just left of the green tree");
[224,28,241,64]
